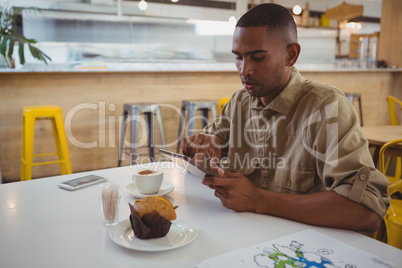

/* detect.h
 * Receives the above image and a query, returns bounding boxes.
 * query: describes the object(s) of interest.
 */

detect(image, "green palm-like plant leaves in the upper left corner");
[0,5,51,68]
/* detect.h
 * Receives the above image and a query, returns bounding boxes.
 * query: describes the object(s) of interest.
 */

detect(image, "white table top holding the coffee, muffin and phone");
[0,162,402,268]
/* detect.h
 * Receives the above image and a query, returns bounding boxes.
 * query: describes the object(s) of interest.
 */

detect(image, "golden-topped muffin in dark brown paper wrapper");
[129,196,177,239]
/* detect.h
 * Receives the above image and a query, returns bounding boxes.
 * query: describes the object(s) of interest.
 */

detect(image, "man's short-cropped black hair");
[236,4,297,43]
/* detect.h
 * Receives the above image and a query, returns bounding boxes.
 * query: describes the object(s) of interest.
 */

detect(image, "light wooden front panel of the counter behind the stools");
[0,71,402,182]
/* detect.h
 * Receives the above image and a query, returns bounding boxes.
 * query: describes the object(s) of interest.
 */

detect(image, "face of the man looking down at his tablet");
[232,27,290,98]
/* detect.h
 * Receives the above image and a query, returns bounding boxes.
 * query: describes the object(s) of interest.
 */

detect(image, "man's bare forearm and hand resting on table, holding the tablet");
[202,168,380,232]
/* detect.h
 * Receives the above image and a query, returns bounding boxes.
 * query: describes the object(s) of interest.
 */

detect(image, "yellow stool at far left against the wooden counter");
[21,105,72,181]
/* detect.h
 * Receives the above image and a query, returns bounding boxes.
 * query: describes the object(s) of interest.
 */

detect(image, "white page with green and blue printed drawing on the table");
[197,229,395,268]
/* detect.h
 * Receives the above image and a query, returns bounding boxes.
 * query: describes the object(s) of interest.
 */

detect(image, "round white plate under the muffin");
[109,219,199,251]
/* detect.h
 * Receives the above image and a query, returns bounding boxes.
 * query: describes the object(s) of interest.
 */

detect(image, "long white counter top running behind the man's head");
[0,62,402,73]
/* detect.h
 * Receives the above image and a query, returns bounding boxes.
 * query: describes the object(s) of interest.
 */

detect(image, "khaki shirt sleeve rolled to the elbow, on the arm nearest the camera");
[310,94,390,218]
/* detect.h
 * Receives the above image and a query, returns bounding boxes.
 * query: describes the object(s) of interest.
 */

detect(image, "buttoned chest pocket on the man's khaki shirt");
[274,166,314,193]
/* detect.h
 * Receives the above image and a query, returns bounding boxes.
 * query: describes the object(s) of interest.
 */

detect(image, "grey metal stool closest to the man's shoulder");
[177,100,216,152]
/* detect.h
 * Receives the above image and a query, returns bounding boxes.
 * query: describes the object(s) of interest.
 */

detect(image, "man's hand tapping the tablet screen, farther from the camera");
[181,133,221,162]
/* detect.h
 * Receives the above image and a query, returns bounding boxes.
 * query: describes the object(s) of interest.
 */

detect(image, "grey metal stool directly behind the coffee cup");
[118,103,165,166]
